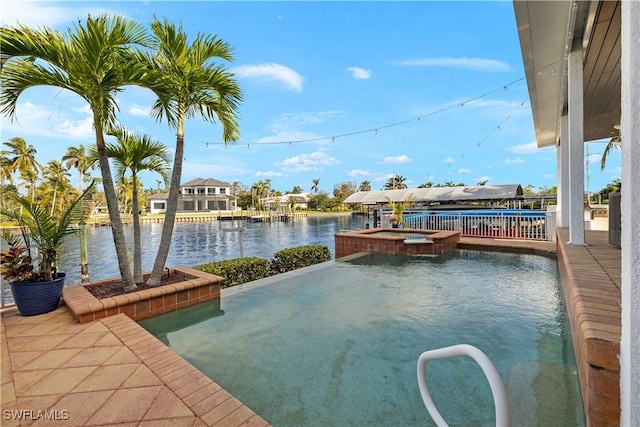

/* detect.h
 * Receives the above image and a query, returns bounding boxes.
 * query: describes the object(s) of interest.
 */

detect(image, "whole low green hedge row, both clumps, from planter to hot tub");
[194,245,331,288]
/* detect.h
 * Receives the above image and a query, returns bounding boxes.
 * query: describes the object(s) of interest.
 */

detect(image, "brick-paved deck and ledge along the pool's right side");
[557,228,622,426]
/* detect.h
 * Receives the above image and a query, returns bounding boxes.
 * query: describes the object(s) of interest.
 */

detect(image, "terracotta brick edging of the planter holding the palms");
[62,266,224,323]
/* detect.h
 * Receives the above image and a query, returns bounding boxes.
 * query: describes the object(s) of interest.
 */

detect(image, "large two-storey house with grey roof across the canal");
[149,178,236,214]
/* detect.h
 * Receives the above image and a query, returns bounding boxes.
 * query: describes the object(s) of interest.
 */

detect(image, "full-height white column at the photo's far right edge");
[620,1,640,426]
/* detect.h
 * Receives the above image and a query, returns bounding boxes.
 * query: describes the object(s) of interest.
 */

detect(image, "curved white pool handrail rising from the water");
[418,344,511,427]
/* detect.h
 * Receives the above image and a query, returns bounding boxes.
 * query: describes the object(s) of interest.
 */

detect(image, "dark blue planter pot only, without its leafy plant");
[11,273,66,316]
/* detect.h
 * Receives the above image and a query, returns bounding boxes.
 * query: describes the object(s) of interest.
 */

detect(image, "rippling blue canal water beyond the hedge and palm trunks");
[60,215,366,285]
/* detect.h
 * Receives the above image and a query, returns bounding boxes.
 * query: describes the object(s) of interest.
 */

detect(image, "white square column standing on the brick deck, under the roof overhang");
[567,50,584,245]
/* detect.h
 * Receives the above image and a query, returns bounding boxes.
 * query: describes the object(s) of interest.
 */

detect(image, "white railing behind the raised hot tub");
[403,211,555,240]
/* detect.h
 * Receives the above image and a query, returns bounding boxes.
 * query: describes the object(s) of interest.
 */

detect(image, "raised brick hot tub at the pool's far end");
[335,228,460,258]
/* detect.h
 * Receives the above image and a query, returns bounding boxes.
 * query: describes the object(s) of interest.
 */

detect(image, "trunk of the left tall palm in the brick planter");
[94,120,137,292]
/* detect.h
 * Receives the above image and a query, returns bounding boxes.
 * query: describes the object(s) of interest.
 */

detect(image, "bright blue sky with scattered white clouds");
[0,0,621,193]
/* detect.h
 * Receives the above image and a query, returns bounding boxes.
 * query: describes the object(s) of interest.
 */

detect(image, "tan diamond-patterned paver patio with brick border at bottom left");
[0,307,268,427]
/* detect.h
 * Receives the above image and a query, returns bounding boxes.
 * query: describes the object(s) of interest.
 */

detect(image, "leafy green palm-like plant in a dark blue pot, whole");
[0,184,93,316]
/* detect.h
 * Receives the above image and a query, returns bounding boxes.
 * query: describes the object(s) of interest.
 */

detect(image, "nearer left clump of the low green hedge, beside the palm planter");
[194,257,271,288]
